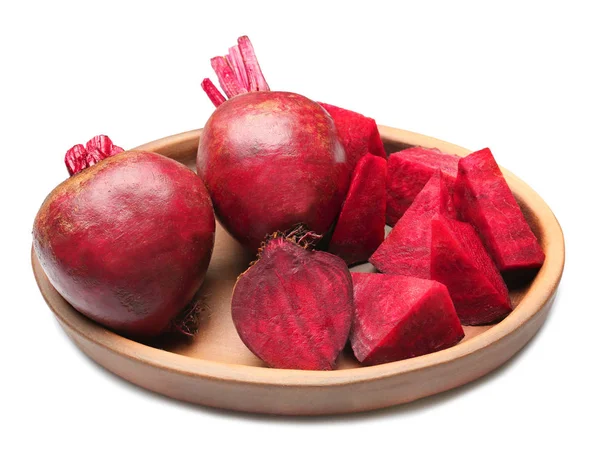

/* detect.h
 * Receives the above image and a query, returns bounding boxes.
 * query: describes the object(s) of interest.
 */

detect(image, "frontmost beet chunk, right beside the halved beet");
[350,273,464,365]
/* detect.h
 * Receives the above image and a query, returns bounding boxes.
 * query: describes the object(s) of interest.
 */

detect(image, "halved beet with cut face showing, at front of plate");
[231,230,353,370]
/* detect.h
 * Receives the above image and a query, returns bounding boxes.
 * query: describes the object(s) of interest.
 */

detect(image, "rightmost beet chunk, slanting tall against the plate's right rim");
[454,148,545,277]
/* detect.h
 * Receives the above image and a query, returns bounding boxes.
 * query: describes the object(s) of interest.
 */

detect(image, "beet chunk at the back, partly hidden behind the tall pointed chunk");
[386,147,460,226]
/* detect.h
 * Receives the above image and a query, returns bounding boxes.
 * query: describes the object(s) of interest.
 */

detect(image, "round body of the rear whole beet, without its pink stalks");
[197,91,351,249]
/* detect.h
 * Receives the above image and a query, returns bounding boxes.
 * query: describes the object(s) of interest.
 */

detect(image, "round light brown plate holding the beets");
[32,126,565,414]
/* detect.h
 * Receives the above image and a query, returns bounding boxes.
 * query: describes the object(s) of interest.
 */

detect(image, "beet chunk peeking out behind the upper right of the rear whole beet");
[319,102,387,168]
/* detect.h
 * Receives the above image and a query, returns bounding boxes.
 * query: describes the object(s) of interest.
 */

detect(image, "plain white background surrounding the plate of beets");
[0,0,600,452]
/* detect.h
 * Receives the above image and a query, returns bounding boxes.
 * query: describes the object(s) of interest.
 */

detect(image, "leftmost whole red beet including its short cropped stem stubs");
[33,138,215,337]
